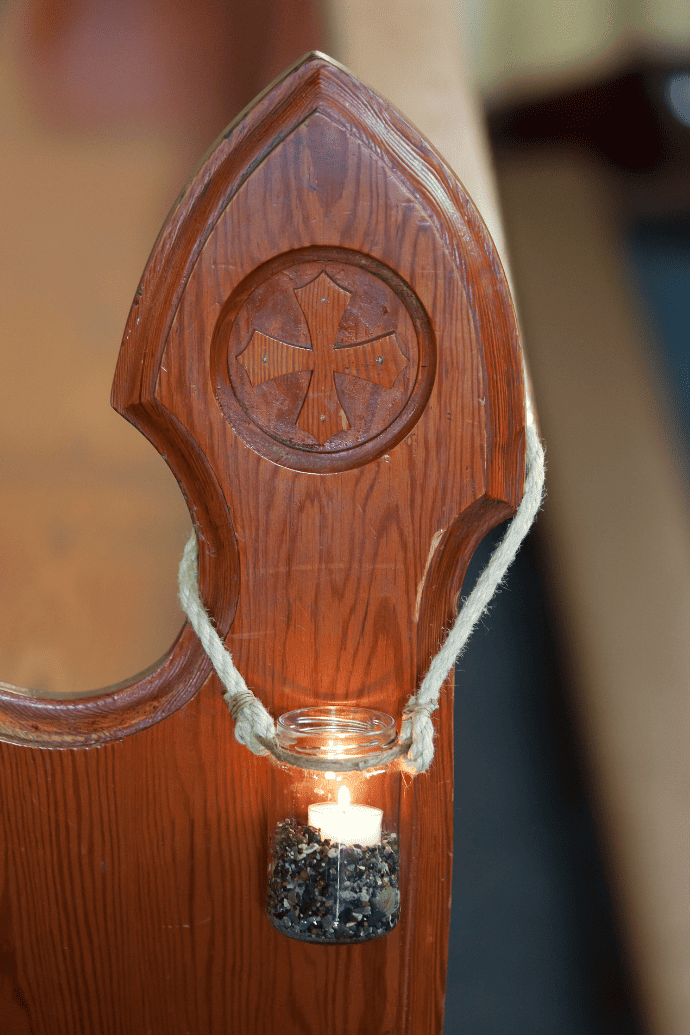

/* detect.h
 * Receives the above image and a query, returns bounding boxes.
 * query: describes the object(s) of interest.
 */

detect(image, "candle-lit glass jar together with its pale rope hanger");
[179,400,544,944]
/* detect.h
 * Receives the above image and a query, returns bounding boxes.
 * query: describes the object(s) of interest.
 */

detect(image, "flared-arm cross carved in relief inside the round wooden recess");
[238,271,408,445]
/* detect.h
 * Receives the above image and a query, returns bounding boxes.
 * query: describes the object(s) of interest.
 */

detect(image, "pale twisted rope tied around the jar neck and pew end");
[178,416,544,775]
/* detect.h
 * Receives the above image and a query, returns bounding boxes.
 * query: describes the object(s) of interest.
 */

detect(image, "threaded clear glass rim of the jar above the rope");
[276,704,397,762]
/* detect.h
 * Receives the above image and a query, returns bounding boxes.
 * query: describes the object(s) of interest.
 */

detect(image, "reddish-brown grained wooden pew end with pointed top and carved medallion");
[0,55,524,1035]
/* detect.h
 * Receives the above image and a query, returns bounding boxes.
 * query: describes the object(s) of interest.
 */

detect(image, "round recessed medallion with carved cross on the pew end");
[211,248,434,473]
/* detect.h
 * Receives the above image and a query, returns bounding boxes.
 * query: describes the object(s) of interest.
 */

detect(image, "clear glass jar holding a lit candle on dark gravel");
[268,705,401,944]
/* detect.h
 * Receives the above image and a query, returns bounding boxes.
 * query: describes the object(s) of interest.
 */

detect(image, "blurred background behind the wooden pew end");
[0,0,690,1035]
